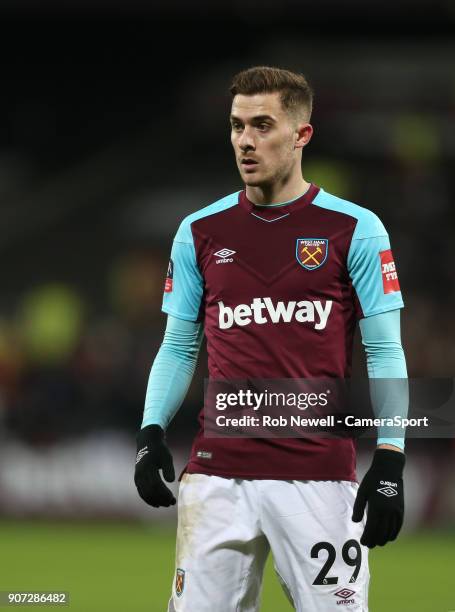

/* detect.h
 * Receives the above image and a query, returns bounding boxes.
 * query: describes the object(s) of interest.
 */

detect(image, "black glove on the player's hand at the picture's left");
[134,425,175,508]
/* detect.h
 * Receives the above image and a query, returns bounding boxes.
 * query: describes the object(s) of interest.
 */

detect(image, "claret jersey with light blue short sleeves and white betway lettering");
[163,184,403,480]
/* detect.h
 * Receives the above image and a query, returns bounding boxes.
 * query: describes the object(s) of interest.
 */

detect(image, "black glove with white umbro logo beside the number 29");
[352,448,405,548]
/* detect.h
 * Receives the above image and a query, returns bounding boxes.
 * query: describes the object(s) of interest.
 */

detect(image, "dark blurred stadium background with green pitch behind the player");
[0,0,455,612]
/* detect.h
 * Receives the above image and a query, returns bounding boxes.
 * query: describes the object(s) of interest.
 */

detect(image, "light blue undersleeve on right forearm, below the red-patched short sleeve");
[359,310,409,449]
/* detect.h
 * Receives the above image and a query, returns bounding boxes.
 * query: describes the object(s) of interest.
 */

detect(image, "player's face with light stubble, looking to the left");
[231,92,301,187]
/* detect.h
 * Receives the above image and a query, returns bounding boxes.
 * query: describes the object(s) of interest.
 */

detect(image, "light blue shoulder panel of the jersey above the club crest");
[313,189,387,240]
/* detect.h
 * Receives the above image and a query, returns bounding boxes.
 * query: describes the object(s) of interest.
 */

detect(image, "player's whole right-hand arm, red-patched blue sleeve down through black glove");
[347,211,408,548]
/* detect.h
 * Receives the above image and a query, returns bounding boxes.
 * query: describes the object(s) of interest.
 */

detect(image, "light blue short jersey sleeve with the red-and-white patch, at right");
[347,209,403,317]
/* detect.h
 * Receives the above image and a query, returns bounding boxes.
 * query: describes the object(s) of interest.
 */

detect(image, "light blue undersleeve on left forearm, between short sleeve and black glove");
[142,315,204,430]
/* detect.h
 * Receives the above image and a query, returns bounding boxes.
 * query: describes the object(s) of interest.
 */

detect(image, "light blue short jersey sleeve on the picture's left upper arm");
[161,217,204,321]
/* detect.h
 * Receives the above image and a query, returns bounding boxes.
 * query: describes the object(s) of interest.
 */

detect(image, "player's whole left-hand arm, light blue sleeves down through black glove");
[134,217,203,507]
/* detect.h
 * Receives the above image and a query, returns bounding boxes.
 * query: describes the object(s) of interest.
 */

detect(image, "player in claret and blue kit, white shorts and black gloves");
[135,66,407,612]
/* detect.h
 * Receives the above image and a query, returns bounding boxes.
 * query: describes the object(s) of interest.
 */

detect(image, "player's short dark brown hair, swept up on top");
[229,66,313,121]
